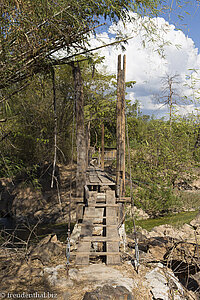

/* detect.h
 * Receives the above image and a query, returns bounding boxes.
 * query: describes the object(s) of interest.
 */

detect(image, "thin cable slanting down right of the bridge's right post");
[126,109,140,272]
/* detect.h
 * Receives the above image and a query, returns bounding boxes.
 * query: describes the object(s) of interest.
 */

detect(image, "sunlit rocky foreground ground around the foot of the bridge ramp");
[0,214,200,300]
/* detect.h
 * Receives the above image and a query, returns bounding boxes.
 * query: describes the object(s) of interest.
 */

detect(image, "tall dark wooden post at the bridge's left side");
[73,63,87,197]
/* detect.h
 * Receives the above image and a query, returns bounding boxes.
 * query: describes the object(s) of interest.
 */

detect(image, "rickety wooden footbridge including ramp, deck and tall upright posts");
[72,55,126,265]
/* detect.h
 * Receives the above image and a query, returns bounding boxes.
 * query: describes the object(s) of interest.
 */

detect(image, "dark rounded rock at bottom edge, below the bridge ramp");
[83,285,134,300]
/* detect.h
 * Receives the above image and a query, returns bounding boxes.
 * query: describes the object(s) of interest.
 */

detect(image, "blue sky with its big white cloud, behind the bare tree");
[91,1,200,118]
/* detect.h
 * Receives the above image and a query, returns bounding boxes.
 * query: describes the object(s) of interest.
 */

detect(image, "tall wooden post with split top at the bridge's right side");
[116,55,126,197]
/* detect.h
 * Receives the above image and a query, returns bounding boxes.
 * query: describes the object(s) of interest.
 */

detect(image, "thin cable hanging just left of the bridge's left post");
[66,74,76,276]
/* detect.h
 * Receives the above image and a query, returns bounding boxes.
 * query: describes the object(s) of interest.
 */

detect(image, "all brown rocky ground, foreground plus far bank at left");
[0,166,200,300]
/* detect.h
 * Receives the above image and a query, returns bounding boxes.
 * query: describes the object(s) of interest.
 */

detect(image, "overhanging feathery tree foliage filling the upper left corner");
[0,0,161,94]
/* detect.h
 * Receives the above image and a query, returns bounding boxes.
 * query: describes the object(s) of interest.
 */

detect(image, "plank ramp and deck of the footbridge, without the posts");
[76,167,120,265]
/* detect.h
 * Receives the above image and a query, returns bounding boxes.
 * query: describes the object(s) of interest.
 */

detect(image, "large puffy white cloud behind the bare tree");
[91,14,200,116]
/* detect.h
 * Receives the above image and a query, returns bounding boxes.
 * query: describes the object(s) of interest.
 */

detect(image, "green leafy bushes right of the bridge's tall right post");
[127,103,199,216]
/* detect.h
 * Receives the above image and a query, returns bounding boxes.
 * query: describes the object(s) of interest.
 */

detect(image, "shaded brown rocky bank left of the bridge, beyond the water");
[0,165,76,224]
